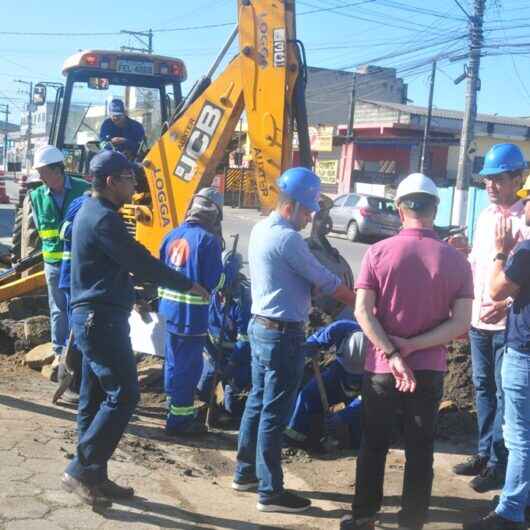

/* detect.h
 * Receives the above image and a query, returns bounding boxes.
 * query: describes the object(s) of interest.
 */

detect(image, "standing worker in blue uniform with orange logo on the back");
[159,188,223,436]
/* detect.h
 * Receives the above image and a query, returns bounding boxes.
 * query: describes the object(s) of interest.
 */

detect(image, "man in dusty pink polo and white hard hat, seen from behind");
[340,173,473,530]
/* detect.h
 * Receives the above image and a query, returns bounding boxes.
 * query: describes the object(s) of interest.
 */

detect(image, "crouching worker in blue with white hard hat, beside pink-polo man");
[284,320,367,448]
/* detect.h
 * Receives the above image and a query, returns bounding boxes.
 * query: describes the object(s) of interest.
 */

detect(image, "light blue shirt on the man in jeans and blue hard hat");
[248,212,341,322]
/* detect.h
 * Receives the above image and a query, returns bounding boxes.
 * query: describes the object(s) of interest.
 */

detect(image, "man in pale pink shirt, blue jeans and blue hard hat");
[454,144,527,493]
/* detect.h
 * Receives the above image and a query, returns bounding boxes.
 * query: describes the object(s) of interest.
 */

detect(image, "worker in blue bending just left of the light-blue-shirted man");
[197,250,252,418]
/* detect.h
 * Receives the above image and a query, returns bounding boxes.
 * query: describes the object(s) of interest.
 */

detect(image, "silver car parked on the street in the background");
[329,193,401,241]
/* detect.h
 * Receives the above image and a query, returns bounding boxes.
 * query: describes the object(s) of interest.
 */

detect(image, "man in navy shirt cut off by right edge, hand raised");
[464,177,530,530]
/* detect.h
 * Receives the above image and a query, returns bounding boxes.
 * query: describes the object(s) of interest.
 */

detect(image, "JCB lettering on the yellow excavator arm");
[174,102,223,182]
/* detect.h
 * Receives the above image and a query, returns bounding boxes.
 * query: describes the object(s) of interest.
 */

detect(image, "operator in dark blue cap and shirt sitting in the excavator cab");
[99,99,145,156]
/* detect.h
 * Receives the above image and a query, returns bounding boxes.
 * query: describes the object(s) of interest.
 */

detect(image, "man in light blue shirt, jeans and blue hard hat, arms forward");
[232,167,355,512]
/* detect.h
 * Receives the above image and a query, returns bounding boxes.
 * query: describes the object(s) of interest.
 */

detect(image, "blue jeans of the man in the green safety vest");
[44,263,68,355]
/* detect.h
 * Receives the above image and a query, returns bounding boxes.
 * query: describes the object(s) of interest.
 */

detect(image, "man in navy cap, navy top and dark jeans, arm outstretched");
[62,151,204,507]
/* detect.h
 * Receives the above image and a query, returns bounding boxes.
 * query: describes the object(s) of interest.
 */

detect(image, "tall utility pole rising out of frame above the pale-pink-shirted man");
[452,0,486,226]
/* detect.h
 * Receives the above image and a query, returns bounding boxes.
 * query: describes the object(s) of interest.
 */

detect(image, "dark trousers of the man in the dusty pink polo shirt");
[352,370,444,529]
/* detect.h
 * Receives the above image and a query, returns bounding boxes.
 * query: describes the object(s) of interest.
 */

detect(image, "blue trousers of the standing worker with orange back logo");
[164,332,206,432]
